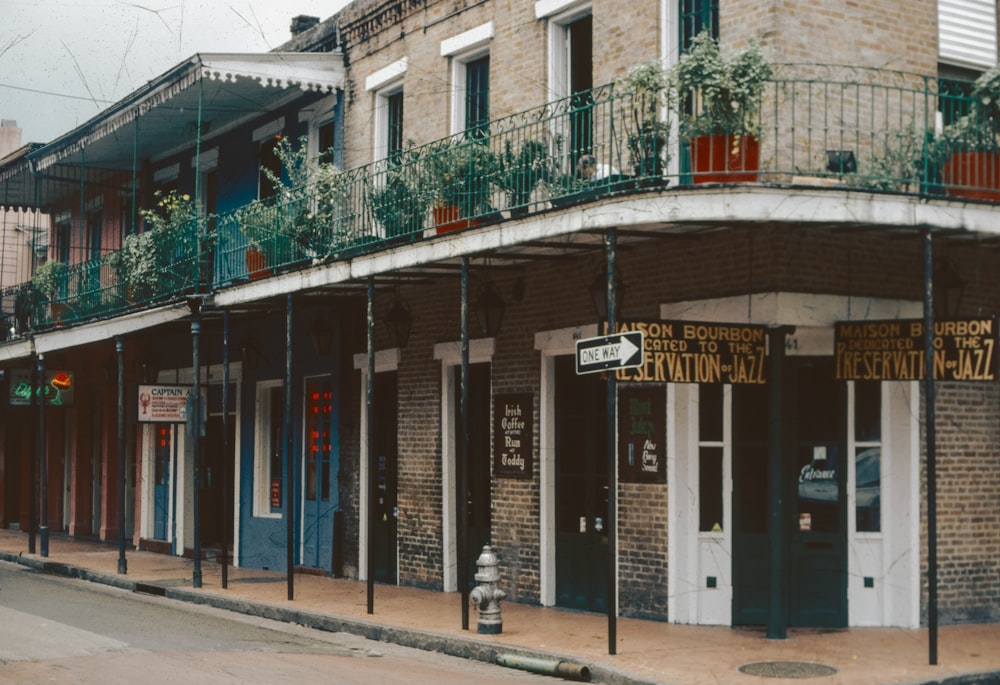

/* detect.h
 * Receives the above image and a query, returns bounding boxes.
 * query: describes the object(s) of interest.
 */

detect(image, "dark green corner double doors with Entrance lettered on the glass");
[733,357,847,627]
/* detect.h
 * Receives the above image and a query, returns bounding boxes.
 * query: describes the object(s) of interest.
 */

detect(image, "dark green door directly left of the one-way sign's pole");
[555,356,608,611]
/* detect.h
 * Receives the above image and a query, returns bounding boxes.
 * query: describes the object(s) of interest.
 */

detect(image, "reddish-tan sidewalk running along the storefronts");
[0,530,1000,685]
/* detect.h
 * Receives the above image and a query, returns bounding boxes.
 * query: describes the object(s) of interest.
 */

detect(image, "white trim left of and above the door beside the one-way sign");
[535,324,597,606]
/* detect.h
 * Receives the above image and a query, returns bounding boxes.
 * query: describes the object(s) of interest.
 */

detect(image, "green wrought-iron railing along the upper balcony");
[0,65,988,335]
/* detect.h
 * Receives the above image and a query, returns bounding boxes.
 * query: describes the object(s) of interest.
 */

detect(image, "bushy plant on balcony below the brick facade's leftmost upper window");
[368,146,430,238]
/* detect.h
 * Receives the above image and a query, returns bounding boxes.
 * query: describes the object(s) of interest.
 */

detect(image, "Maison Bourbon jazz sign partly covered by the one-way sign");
[617,321,767,384]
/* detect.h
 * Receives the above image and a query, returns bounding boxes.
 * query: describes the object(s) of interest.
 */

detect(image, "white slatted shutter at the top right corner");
[938,0,997,69]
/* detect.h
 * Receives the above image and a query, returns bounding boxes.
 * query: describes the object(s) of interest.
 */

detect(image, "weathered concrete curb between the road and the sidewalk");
[0,551,664,685]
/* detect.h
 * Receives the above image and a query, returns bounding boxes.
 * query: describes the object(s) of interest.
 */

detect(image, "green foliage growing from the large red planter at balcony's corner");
[671,32,774,137]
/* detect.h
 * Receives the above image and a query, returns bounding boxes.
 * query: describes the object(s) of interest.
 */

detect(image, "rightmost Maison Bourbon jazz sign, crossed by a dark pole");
[834,319,997,381]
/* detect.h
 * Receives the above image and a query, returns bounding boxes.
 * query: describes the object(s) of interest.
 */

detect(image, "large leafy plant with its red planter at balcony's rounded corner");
[671,32,774,183]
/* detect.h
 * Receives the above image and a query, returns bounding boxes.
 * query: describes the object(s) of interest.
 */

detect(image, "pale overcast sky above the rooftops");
[0,0,350,143]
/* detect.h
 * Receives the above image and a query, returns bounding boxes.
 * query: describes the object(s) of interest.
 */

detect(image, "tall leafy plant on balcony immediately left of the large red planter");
[619,60,670,182]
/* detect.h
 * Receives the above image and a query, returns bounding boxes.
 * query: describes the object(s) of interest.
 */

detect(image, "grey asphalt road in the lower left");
[0,562,554,685]
